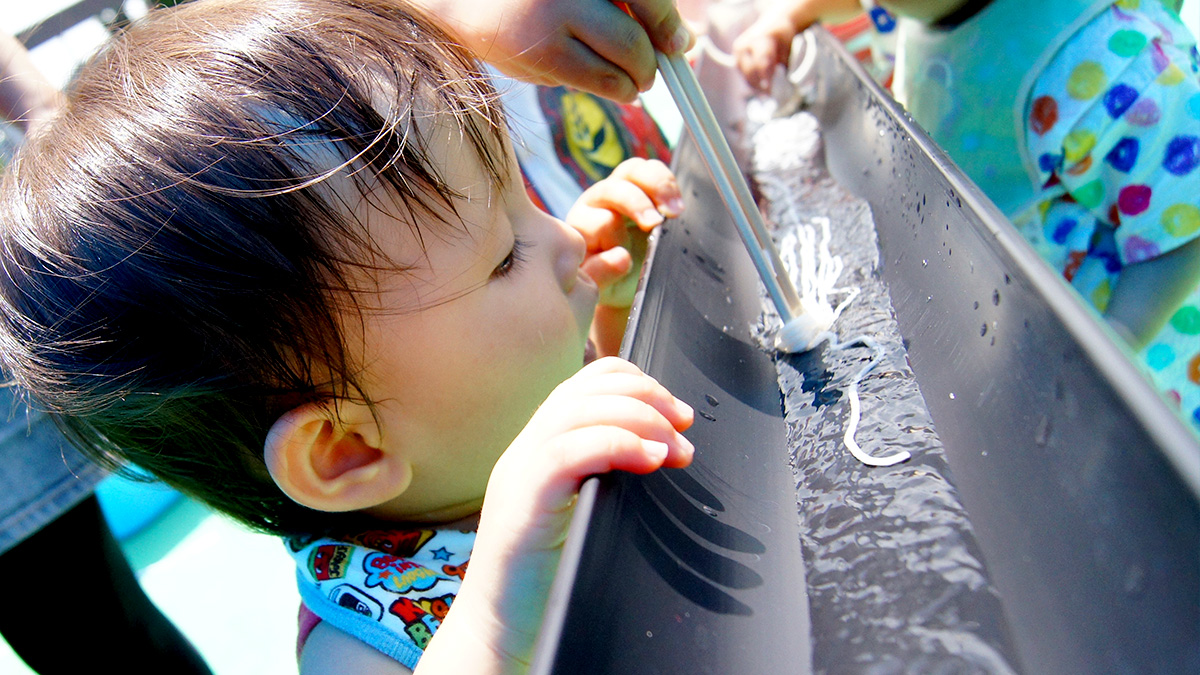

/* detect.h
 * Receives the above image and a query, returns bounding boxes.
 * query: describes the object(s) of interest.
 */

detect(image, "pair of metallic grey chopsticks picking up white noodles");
[655,50,804,325]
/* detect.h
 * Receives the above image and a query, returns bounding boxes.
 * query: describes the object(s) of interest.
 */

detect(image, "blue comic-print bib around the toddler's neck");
[286,530,475,668]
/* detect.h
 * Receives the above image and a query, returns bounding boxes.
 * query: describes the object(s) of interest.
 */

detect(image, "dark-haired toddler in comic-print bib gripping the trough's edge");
[0,0,692,673]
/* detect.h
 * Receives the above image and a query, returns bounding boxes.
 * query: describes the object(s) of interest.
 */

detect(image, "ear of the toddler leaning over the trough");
[264,400,413,512]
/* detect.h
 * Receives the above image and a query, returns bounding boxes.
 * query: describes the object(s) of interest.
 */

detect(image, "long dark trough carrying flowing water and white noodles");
[534,30,1200,674]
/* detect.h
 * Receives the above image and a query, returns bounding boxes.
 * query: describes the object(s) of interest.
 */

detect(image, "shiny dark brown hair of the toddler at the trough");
[0,0,508,533]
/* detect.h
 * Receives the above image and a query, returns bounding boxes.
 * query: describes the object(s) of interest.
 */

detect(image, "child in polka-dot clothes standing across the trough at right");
[736,0,1200,430]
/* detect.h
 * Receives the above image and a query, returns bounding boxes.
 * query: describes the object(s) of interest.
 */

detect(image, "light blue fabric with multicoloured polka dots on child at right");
[1014,0,1200,430]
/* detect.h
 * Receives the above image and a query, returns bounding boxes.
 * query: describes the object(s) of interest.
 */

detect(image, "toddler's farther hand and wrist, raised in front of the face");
[566,159,683,357]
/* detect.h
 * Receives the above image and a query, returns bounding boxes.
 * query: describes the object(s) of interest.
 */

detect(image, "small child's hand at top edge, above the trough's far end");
[733,0,863,91]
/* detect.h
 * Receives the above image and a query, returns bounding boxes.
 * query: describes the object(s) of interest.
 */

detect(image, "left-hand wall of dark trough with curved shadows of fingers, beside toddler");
[533,107,811,675]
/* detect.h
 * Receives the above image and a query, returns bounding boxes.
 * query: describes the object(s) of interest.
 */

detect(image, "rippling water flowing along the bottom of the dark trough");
[751,113,1019,674]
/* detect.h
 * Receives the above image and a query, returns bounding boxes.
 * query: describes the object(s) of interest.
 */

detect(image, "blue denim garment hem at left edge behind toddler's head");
[0,387,104,554]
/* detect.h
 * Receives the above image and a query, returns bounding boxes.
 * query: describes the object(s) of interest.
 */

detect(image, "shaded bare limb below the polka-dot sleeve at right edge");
[1104,239,1200,352]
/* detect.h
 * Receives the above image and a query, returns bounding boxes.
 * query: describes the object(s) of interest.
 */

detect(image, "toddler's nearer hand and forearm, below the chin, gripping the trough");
[434,358,692,673]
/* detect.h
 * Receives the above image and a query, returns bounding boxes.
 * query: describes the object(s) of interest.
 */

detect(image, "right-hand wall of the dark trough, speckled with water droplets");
[814,32,1200,674]
